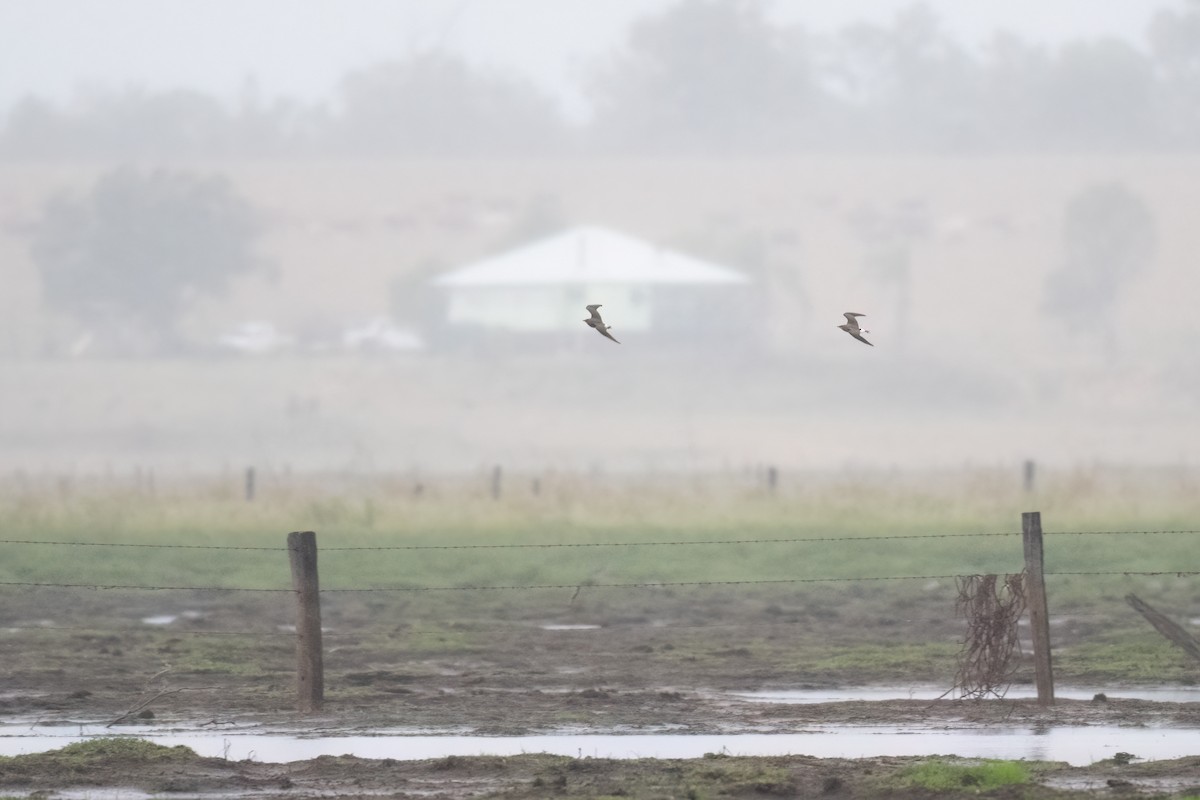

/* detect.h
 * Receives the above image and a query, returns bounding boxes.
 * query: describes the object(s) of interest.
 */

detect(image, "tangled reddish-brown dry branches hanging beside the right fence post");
[950,573,1025,697]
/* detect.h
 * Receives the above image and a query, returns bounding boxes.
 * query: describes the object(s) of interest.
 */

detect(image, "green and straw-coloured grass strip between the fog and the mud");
[0,467,1200,589]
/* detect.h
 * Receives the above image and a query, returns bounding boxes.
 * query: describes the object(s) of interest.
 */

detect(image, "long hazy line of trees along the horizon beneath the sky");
[0,0,1200,160]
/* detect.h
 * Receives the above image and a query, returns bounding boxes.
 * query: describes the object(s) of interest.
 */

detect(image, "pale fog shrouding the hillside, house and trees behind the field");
[0,0,1200,480]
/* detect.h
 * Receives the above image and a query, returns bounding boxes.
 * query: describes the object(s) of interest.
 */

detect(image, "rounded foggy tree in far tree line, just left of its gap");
[338,53,565,155]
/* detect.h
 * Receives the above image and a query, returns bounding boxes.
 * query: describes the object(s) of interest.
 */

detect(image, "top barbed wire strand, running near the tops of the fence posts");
[0,530,1200,553]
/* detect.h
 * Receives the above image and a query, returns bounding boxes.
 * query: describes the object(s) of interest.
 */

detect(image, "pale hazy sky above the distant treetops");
[0,0,1182,118]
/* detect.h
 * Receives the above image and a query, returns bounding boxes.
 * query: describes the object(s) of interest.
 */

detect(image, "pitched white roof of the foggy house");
[433,227,748,287]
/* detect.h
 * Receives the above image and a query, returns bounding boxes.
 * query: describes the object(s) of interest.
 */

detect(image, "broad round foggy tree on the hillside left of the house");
[32,168,258,351]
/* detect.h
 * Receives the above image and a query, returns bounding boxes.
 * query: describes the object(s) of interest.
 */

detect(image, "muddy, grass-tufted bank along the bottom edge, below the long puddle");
[0,740,1200,800]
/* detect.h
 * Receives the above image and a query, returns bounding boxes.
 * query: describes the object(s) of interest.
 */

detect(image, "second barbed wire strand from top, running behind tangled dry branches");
[0,570,1200,594]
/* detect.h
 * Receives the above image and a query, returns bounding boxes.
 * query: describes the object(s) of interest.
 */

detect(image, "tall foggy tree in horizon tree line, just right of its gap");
[589,0,821,152]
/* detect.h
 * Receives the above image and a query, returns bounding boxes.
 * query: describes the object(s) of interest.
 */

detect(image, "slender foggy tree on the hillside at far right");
[1043,184,1156,357]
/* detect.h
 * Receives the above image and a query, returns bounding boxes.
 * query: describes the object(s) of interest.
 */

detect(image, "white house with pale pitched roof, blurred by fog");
[432,225,750,341]
